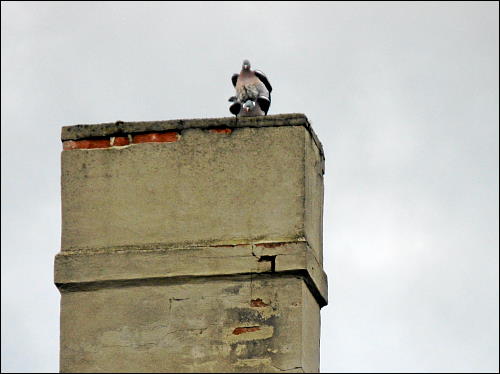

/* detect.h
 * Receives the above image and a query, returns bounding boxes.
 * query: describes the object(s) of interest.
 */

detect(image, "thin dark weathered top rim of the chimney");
[61,113,325,159]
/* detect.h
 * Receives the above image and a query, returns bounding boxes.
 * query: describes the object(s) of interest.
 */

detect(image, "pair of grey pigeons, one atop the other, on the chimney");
[229,60,273,117]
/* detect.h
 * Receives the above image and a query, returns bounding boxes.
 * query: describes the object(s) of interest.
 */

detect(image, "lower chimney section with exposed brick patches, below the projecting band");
[61,275,319,372]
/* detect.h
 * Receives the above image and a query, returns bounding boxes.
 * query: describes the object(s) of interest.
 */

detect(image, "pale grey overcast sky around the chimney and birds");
[1,2,499,372]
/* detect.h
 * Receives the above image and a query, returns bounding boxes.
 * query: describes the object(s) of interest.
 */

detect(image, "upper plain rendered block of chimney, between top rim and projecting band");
[62,122,322,262]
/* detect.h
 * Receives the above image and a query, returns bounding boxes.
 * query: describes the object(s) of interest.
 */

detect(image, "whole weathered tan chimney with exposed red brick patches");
[54,114,327,372]
